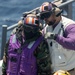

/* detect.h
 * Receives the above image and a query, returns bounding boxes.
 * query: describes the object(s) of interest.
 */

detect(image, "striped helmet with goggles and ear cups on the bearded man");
[39,2,62,20]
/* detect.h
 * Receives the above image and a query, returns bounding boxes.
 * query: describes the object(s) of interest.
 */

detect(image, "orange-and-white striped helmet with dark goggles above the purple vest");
[23,16,39,33]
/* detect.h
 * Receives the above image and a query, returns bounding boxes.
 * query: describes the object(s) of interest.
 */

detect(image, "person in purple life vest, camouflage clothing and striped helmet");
[2,14,51,75]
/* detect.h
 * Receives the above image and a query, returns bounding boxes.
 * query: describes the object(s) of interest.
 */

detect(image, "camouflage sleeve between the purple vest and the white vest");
[34,40,51,75]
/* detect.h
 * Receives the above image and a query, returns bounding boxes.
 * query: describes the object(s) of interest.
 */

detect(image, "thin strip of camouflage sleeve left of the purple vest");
[2,41,9,75]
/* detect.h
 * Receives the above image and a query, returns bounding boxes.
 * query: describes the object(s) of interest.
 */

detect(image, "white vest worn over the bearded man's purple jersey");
[45,16,75,72]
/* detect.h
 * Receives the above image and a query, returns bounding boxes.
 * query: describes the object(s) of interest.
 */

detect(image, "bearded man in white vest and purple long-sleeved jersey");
[39,2,75,75]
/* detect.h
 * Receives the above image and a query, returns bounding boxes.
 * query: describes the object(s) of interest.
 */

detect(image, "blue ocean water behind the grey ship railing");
[0,0,75,49]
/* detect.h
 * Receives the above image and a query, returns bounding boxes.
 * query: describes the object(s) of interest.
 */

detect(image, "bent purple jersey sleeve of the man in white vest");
[56,24,75,50]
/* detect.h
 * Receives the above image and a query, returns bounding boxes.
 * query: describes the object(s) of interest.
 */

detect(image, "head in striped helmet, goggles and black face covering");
[22,14,41,40]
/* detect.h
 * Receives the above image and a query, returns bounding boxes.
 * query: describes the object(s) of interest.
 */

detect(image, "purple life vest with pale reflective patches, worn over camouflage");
[7,35,43,75]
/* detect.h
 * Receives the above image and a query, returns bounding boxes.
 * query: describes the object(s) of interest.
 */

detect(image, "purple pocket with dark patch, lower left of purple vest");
[8,54,19,73]
